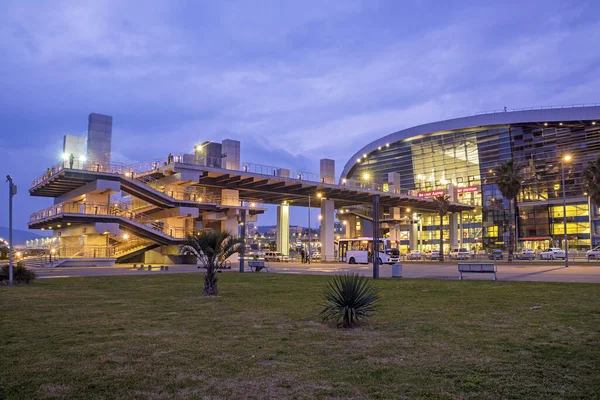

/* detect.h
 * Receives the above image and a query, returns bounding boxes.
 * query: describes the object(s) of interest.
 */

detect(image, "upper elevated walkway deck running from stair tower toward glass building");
[29,156,476,214]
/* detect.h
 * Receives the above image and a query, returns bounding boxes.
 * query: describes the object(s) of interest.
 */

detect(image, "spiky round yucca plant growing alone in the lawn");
[321,274,380,328]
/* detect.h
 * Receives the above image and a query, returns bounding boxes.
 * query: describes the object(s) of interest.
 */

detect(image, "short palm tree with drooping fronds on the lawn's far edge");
[180,230,244,296]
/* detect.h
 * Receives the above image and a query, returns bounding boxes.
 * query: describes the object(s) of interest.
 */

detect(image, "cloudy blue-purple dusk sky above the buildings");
[0,0,600,229]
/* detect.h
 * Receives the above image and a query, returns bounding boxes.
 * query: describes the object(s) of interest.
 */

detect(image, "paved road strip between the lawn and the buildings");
[34,263,600,283]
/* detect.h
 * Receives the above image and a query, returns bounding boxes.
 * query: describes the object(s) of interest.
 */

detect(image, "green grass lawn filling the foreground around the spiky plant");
[0,273,600,399]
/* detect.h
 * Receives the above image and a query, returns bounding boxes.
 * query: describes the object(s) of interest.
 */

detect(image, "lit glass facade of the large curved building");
[342,115,600,250]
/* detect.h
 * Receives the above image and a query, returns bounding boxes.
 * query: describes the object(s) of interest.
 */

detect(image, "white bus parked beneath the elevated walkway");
[338,237,400,264]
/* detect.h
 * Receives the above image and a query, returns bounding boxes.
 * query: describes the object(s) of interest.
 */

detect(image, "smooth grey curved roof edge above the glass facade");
[340,106,600,179]
